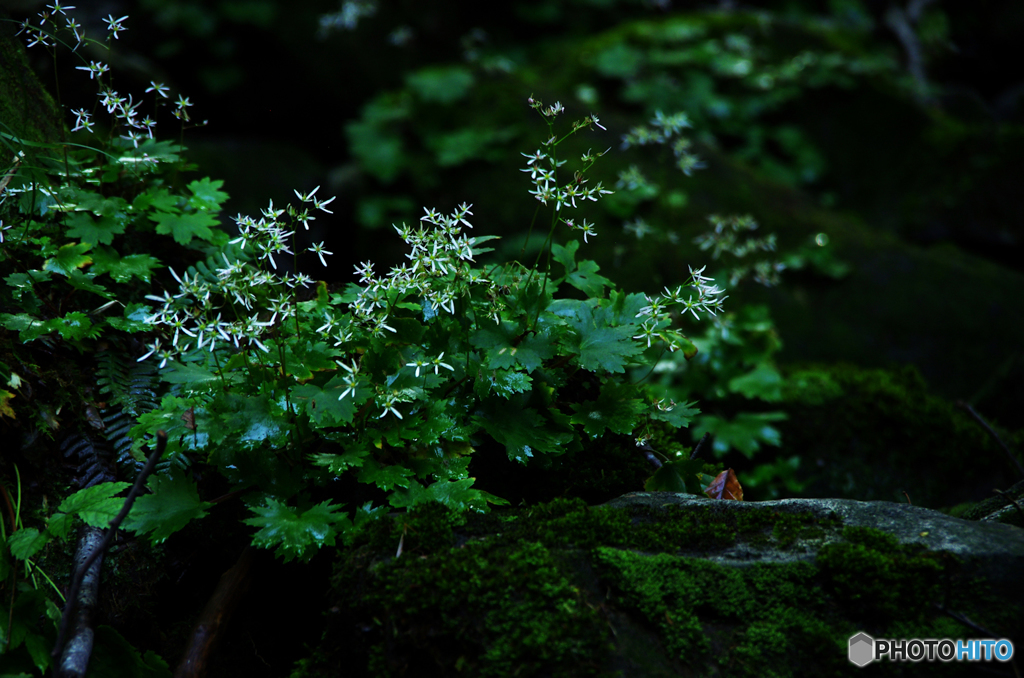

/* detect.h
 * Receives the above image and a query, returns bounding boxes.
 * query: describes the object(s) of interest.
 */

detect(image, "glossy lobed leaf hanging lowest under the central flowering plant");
[243,498,349,562]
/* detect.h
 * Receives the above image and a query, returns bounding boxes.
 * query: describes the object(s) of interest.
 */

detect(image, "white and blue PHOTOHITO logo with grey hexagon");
[847,632,1014,667]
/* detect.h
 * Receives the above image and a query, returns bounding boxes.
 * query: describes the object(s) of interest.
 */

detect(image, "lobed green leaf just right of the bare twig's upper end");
[123,466,213,544]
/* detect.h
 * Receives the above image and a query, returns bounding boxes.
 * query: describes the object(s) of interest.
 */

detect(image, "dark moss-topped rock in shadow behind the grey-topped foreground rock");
[777,365,1024,508]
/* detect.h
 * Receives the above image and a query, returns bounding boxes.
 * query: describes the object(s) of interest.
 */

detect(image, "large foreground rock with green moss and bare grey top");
[293,493,1024,677]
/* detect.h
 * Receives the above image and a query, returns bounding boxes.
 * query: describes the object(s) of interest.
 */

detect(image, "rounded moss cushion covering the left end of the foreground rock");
[335,542,608,676]
